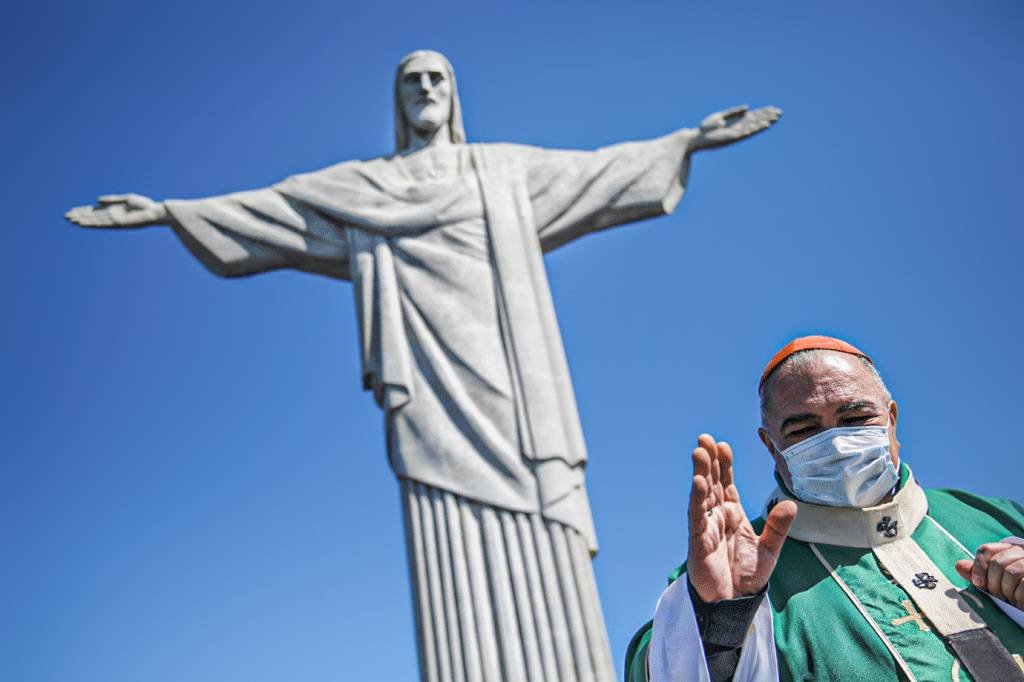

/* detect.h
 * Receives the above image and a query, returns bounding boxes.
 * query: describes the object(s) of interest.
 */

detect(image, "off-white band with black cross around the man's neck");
[761,469,928,547]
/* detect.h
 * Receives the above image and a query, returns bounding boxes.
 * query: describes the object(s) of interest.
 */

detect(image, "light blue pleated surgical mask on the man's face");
[781,426,899,507]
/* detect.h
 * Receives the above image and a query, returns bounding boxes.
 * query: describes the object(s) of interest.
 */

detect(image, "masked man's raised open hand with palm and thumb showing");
[686,433,797,602]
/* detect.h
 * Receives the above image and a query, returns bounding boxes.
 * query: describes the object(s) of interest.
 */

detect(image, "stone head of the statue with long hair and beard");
[394,50,466,152]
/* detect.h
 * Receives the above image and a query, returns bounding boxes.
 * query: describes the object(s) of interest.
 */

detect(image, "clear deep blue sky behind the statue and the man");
[0,0,1024,682]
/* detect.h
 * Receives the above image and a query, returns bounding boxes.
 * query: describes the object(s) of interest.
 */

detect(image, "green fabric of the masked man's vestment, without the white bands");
[626,466,1024,682]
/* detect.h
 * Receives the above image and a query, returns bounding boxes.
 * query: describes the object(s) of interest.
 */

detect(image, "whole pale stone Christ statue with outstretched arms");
[68,51,780,682]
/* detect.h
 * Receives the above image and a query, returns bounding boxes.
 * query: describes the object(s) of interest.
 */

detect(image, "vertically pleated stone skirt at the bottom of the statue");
[399,479,615,682]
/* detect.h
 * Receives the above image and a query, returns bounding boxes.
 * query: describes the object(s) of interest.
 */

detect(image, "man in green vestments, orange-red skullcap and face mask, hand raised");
[626,336,1024,682]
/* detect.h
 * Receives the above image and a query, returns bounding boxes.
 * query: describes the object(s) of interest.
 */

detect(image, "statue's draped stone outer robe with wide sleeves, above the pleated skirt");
[166,131,688,552]
